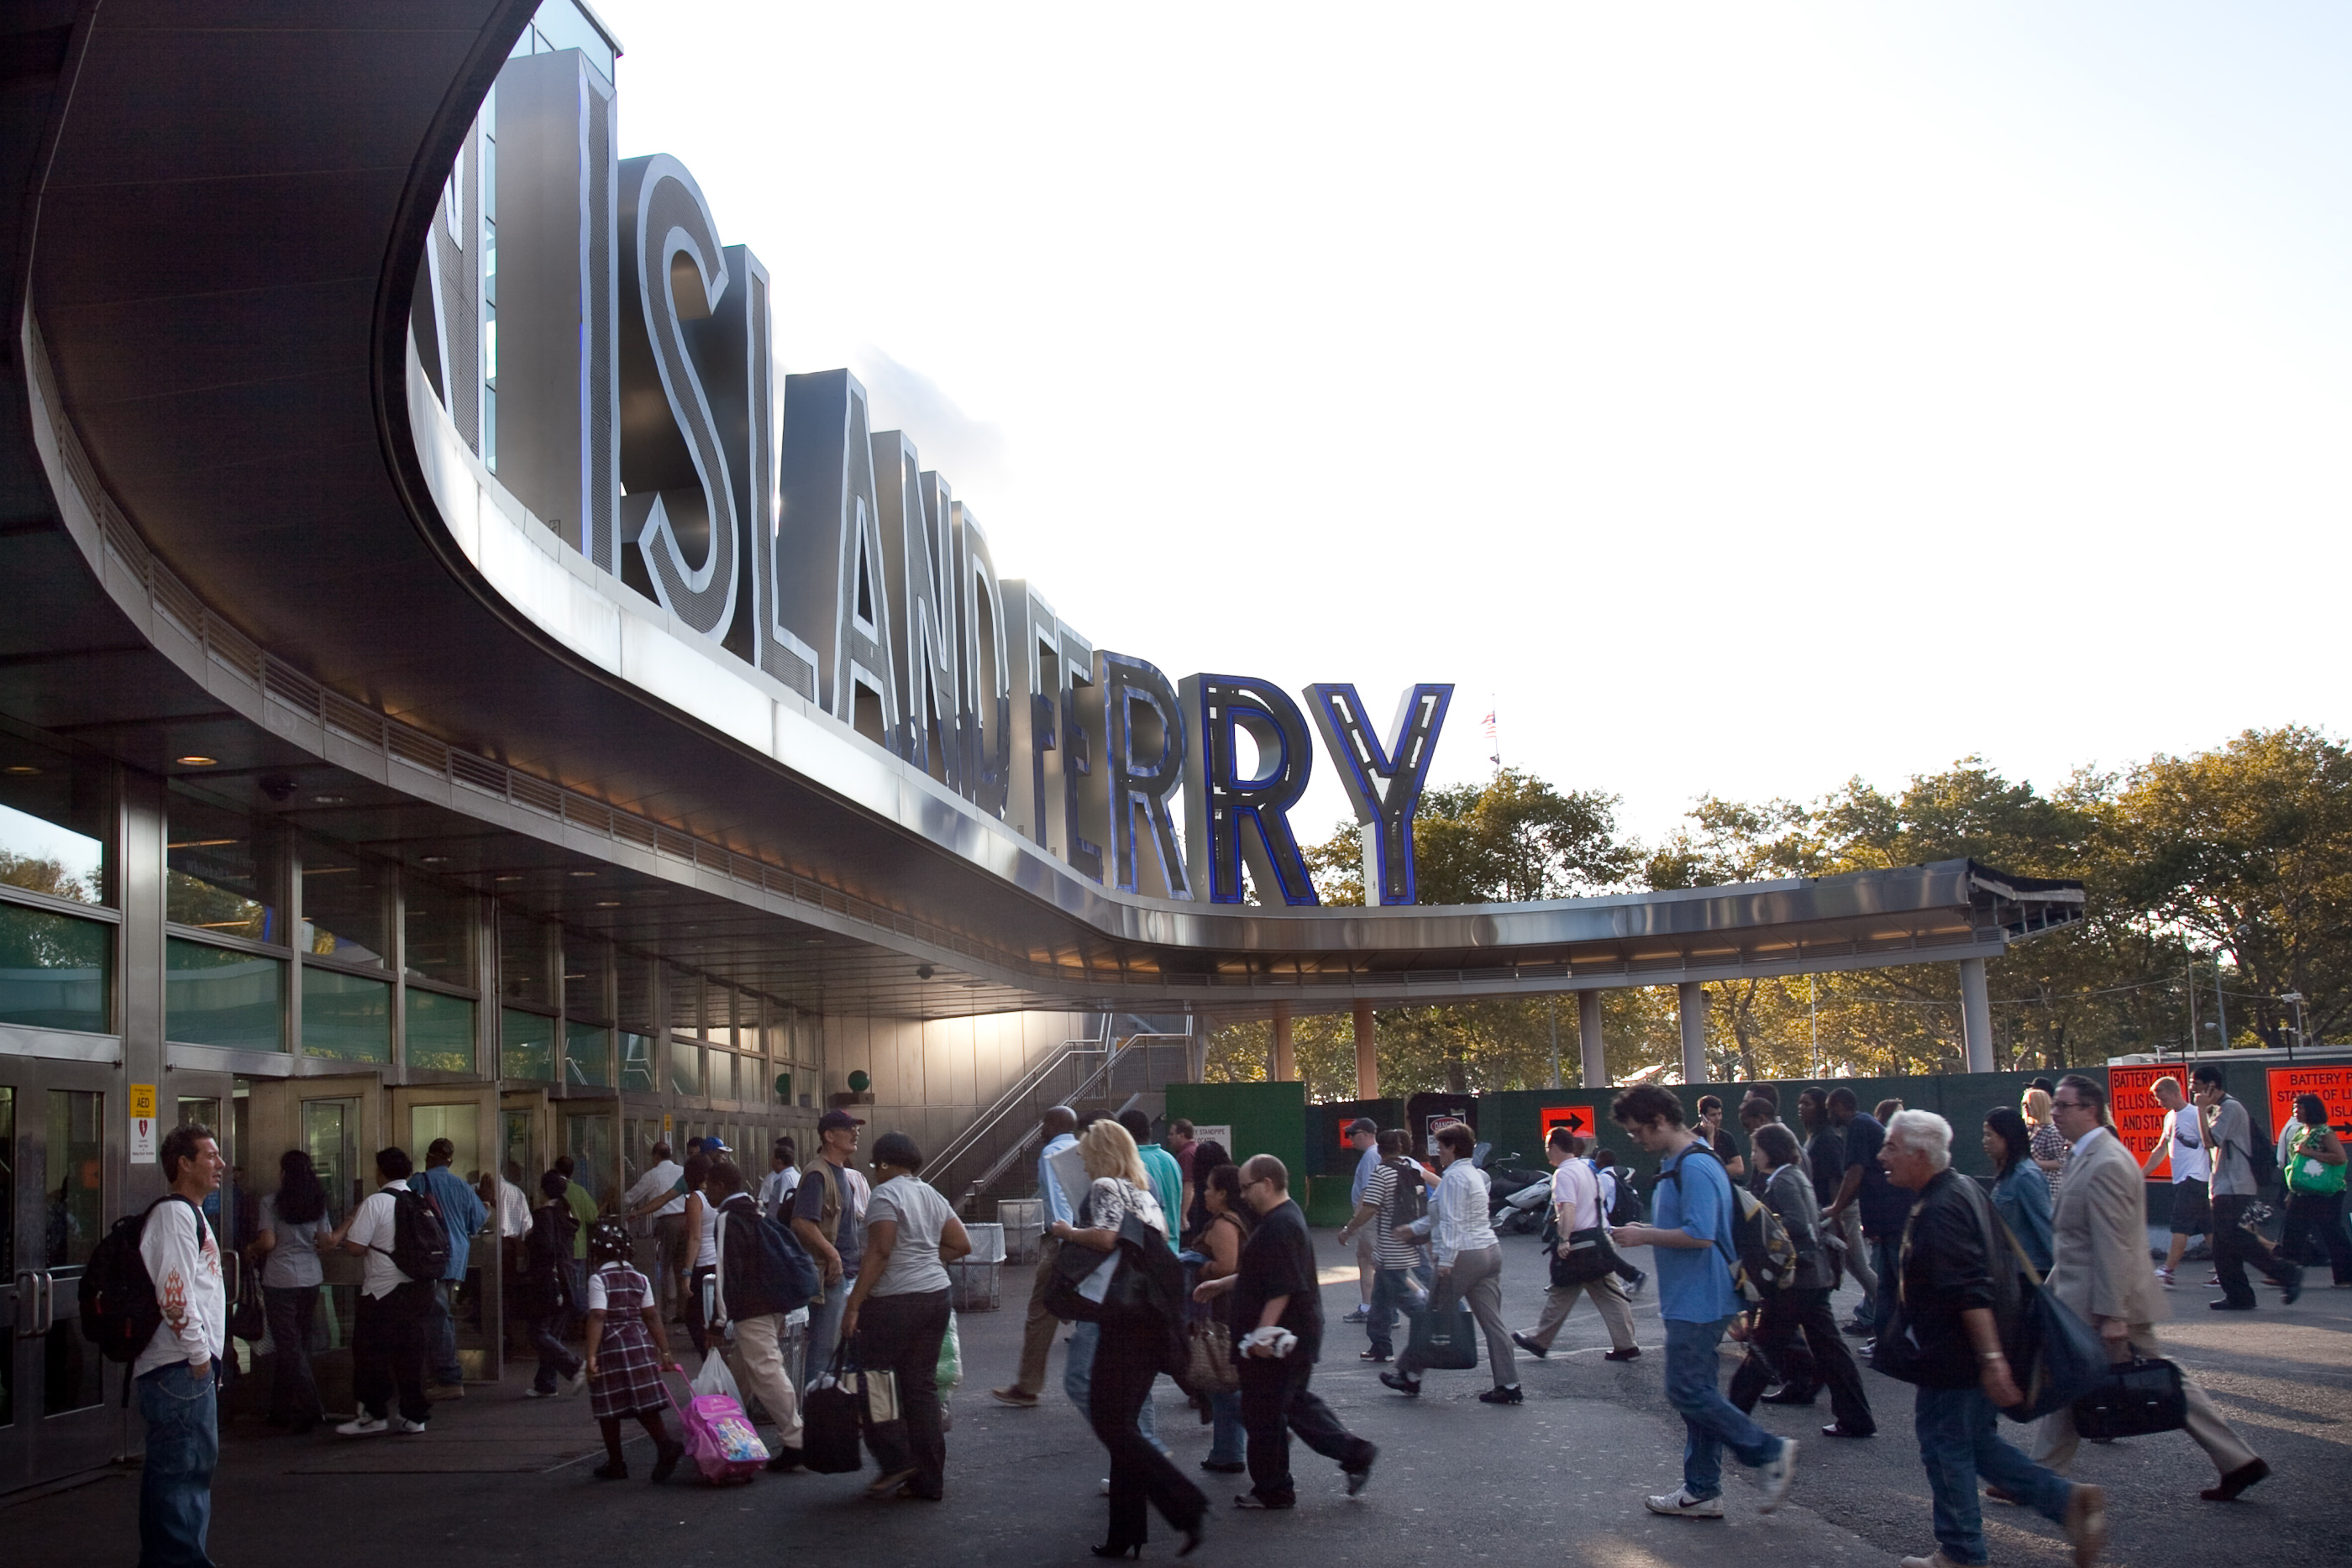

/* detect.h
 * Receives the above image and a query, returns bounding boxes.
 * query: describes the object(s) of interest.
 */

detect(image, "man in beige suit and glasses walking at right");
[2034,1074,2270,1502]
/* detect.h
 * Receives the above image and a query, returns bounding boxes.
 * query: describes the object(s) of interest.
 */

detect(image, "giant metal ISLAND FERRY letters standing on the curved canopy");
[412,50,1453,907]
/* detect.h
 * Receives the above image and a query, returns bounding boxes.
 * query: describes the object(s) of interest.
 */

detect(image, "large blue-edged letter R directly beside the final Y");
[1183,674,1317,907]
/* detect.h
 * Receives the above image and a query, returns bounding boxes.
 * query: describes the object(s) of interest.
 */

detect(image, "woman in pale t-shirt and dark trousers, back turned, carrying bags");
[842,1133,971,1502]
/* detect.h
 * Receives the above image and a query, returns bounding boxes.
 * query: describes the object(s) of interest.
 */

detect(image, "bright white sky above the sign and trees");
[595,0,2352,836]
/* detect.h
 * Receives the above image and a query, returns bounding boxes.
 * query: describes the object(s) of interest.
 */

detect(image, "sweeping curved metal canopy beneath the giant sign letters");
[0,0,2082,1018]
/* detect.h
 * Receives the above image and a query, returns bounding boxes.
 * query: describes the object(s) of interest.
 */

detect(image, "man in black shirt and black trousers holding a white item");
[1193,1154,1381,1509]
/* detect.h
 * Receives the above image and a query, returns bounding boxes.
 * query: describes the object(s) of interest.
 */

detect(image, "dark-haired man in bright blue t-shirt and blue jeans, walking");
[1609,1083,1797,1518]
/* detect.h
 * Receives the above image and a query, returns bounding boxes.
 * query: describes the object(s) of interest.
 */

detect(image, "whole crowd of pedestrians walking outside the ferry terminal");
[134,1065,2352,1568]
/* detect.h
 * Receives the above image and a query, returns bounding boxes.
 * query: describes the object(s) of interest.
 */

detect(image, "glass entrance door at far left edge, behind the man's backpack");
[0,1058,129,1486]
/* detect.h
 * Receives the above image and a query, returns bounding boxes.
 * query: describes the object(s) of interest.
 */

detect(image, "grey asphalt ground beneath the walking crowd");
[0,1232,2352,1568]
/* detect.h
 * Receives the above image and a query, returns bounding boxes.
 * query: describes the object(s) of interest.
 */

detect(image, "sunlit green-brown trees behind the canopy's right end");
[1211,726,2352,1100]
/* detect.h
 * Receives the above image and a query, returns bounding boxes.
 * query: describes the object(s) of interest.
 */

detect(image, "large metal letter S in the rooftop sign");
[618,153,736,637]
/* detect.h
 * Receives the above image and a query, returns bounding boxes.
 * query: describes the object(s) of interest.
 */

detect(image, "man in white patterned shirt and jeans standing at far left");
[132,1121,228,1563]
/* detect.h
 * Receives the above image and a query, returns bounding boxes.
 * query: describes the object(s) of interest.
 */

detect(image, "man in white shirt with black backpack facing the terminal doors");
[320,1147,449,1436]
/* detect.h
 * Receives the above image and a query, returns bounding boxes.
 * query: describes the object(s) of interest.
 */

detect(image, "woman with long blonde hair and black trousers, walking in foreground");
[1053,1117,1209,1556]
